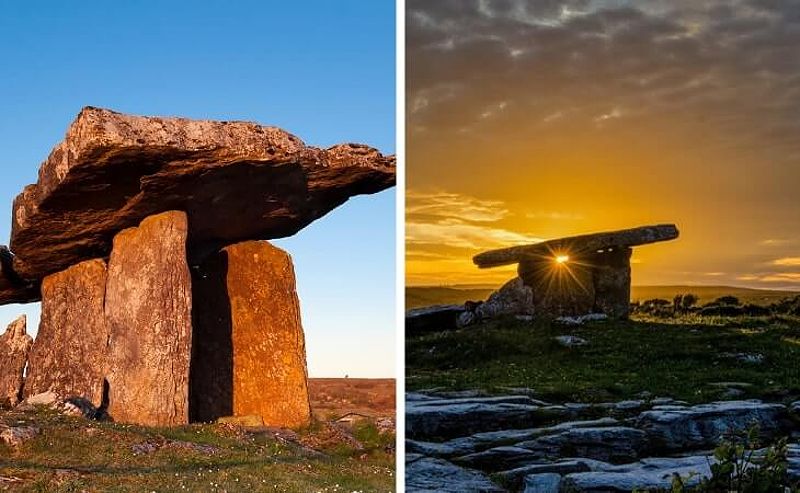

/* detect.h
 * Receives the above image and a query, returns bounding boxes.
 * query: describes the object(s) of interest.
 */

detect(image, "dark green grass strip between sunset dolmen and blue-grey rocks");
[406,315,800,403]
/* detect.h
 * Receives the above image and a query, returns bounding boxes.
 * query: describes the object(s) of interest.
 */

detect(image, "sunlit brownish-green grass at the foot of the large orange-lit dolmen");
[0,410,395,493]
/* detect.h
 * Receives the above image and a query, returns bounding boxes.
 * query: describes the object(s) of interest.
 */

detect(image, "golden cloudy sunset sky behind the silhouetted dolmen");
[406,0,800,289]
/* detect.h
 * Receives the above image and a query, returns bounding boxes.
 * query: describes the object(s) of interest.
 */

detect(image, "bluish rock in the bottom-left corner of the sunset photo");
[405,455,504,493]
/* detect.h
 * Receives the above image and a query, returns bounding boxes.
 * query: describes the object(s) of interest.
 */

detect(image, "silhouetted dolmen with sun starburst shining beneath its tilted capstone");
[472,224,678,323]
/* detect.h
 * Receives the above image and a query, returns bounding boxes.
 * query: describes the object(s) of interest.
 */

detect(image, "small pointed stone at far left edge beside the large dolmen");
[0,315,33,407]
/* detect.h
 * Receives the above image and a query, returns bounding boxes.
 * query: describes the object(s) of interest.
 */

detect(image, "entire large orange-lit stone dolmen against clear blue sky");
[0,107,395,428]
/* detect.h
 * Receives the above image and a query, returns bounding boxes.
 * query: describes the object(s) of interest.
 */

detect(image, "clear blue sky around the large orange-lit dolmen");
[0,0,395,377]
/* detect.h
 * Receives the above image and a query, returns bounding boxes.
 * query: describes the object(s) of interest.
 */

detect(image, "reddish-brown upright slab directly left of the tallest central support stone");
[25,260,108,407]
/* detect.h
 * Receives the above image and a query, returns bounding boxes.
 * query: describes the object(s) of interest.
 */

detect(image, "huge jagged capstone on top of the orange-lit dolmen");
[6,107,395,290]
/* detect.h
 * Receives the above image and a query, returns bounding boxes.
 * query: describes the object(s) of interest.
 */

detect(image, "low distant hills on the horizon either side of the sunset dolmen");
[406,284,800,309]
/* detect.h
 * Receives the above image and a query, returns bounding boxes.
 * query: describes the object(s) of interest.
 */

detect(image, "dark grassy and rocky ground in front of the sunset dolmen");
[406,315,800,493]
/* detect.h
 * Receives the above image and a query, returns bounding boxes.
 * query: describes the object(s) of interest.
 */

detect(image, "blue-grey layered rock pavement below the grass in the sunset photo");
[406,389,800,493]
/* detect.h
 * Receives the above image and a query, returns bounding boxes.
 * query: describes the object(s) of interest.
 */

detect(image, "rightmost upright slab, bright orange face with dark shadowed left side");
[192,241,311,428]
